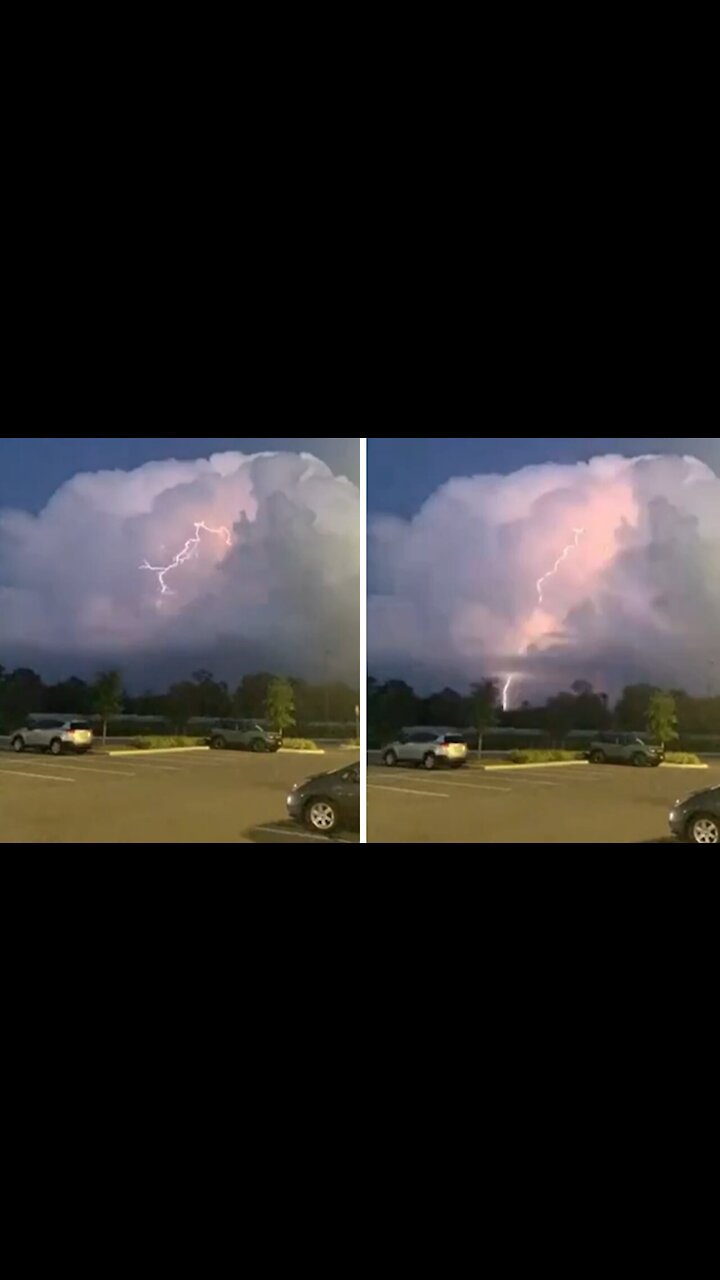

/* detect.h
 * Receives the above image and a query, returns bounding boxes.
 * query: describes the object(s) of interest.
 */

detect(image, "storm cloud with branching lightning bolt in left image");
[0,452,359,685]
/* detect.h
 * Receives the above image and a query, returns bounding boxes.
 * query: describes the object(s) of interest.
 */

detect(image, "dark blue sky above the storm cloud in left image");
[0,435,360,512]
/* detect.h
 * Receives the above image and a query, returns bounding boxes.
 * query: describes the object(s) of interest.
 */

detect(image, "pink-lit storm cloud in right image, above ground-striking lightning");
[368,456,720,704]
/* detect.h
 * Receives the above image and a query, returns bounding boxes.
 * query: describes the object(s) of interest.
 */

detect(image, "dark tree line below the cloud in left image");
[0,666,359,736]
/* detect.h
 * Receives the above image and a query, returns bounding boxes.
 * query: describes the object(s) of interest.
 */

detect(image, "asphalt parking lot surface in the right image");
[368,763,720,845]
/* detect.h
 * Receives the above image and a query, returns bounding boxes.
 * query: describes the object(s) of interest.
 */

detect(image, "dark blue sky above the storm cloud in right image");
[368,435,720,516]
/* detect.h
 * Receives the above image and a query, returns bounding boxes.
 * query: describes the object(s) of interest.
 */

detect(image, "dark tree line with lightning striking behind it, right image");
[368,677,720,750]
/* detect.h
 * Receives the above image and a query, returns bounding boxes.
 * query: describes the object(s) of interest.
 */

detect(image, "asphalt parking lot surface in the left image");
[0,749,359,846]
